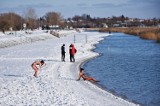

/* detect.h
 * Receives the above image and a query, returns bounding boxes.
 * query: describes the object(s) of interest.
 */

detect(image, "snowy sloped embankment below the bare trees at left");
[0,30,75,48]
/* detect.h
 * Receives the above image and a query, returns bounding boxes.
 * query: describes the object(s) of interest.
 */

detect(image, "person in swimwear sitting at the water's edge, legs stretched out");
[77,68,99,83]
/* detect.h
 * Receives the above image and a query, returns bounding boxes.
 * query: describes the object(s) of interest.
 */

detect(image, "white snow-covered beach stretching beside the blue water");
[0,31,138,106]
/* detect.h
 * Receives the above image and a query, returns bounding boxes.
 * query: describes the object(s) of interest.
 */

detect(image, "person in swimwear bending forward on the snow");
[31,60,45,77]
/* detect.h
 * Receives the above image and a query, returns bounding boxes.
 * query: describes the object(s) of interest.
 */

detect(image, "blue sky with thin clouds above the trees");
[0,0,160,19]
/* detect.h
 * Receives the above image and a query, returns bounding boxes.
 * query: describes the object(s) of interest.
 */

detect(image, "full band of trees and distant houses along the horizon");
[0,8,160,30]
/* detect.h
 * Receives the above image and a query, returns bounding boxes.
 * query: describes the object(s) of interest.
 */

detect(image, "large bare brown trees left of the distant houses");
[0,8,63,30]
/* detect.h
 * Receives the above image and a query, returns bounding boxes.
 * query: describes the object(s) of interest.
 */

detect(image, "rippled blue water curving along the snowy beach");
[83,33,160,106]
